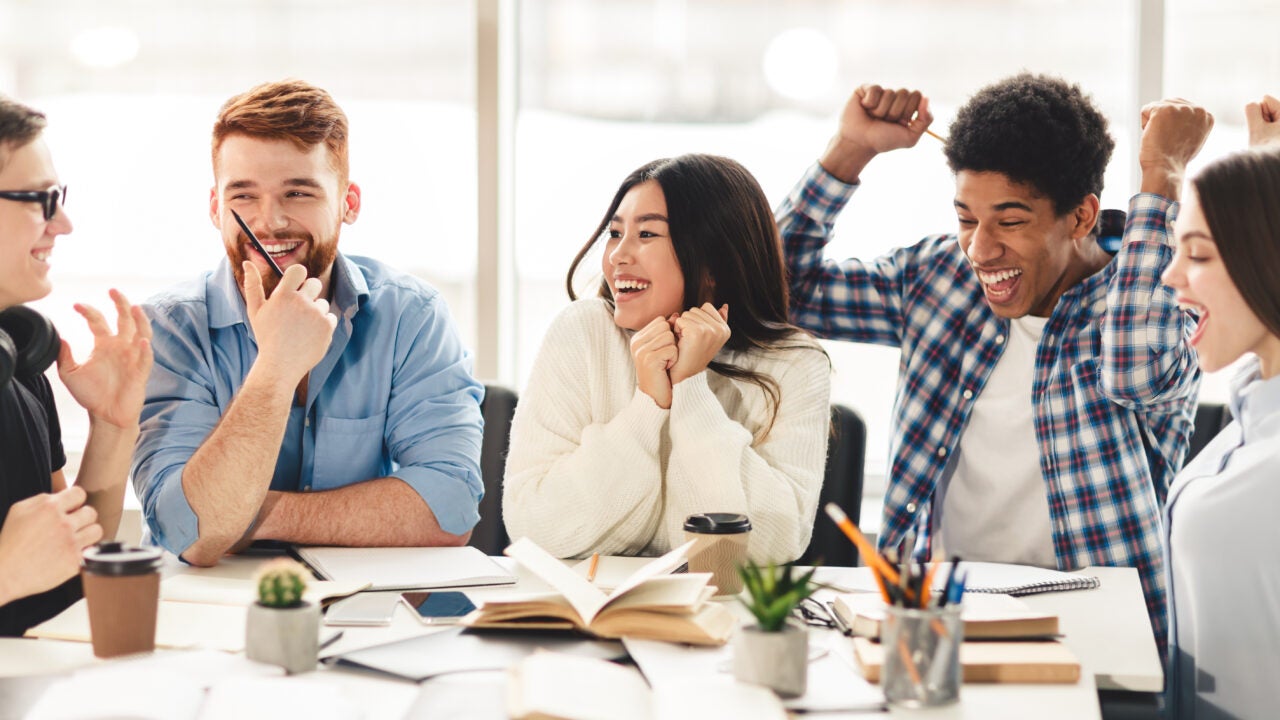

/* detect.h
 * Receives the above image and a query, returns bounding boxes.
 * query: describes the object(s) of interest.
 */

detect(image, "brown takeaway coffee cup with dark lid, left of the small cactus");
[81,542,161,657]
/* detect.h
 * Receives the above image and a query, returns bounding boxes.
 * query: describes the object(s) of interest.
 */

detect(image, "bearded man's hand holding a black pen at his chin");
[244,260,338,386]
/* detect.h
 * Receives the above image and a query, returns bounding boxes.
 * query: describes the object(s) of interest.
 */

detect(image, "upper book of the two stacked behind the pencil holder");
[832,592,1057,639]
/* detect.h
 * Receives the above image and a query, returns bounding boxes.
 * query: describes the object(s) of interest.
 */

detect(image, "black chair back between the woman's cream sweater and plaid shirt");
[799,402,867,568]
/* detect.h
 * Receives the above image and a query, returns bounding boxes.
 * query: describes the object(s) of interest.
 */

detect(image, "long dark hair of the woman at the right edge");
[1192,147,1280,336]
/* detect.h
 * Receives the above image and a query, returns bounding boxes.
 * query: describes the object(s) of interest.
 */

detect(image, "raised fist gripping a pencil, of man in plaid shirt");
[820,85,933,183]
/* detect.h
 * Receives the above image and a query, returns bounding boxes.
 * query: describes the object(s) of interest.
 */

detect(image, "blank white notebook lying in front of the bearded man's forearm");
[294,546,516,591]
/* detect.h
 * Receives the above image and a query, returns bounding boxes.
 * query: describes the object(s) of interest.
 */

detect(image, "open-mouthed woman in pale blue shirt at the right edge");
[1164,122,1280,719]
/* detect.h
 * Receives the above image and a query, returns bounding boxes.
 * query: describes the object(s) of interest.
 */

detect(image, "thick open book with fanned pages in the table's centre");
[462,538,737,644]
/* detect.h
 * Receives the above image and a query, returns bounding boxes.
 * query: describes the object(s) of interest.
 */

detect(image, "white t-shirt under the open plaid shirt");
[934,315,1057,568]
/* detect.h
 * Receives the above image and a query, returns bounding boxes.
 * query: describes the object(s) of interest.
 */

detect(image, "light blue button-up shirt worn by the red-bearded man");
[133,254,484,555]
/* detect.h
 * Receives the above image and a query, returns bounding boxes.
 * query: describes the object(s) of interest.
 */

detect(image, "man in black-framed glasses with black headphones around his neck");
[0,90,151,635]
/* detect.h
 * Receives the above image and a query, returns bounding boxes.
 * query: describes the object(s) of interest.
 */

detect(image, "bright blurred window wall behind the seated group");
[0,0,1280,504]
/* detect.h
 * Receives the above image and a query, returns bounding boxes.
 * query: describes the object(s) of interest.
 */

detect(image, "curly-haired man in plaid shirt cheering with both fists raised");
[777,74,1212,655]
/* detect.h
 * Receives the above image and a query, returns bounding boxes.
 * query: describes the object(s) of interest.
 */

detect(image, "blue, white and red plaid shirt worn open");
[777,164,1201,656]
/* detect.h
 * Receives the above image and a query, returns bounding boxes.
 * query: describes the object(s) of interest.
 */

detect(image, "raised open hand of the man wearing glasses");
[58,290,151,428]
